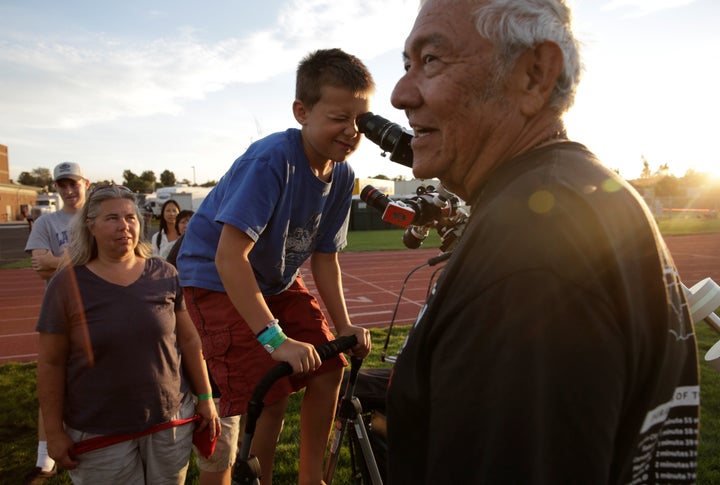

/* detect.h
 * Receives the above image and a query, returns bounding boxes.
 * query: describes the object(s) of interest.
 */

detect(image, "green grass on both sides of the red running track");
[0,217,720,485]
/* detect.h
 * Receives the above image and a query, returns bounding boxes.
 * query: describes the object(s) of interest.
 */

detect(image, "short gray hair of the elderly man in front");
[421,0,583,113]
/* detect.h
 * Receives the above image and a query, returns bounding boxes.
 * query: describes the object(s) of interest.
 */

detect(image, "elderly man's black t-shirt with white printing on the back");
[387,142,699,485]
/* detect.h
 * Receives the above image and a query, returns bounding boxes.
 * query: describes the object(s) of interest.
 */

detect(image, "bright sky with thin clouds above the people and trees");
[0,0,720,184]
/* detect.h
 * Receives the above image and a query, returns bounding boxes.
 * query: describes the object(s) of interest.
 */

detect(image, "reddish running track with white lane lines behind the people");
[0,234,720,363]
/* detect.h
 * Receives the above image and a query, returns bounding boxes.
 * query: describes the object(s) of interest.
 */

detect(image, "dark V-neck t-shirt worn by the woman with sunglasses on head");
[37,258,187,434]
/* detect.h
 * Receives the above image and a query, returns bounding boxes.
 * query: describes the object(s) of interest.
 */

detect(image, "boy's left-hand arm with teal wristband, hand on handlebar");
[215,224,322,373]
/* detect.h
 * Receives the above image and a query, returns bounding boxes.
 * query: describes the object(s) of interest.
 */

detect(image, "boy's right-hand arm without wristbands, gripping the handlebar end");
[310,252,370,359]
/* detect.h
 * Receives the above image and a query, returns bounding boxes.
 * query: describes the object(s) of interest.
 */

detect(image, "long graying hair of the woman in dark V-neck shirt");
[68,185,152,266]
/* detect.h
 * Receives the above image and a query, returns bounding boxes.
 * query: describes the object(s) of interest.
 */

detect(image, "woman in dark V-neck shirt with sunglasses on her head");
[37,185,220,483]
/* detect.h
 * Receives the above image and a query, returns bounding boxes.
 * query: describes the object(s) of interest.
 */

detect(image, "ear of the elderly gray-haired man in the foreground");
[516,41,563,116]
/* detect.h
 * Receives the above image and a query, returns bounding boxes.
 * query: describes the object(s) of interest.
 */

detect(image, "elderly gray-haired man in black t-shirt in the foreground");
[388,0,699,484]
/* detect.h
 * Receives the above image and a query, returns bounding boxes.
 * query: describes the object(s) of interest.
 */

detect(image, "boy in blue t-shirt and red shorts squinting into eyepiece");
[177,49,375,483]
